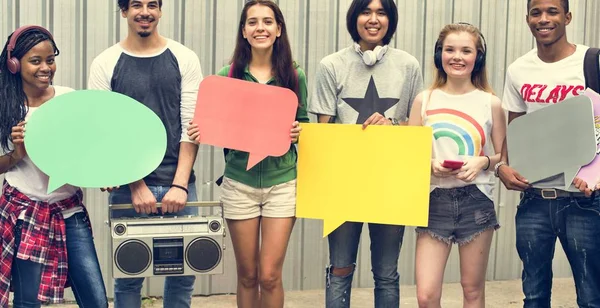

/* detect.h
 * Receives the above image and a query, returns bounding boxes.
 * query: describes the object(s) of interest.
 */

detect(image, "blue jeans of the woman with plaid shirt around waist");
[12,213,108,308]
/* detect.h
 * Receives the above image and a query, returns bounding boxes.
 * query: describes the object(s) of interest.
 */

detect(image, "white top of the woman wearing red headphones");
[4,86,83,219]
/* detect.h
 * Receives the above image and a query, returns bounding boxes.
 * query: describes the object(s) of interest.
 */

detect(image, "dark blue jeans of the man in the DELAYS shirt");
[515,192,600,308]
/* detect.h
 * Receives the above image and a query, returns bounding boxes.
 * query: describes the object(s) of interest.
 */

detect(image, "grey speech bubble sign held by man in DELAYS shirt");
[506,95,596,189]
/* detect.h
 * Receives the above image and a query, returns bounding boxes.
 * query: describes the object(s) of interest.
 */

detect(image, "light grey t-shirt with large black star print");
[308,47,423,124]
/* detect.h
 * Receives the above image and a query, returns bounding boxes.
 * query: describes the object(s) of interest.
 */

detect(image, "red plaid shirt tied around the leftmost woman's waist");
[0,182,91,307]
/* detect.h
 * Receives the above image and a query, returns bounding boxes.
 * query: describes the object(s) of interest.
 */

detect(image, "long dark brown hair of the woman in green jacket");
[231,0,299,94]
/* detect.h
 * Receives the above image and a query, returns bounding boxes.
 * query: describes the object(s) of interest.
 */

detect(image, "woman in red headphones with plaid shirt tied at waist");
[0,26,108,308]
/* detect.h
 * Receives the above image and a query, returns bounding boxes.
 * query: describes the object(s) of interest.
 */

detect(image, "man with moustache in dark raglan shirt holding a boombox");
[88,0,202,308]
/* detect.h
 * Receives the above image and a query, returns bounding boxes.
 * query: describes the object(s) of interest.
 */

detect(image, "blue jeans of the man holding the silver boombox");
[108,183,198,308]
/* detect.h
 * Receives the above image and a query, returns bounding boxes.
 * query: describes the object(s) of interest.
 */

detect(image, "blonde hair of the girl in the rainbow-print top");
[429,23,494,94]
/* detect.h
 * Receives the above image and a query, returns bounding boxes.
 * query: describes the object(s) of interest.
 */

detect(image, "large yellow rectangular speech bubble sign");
[296,124,432,237]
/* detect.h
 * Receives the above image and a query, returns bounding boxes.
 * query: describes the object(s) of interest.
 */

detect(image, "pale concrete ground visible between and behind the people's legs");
[54,278,577,308]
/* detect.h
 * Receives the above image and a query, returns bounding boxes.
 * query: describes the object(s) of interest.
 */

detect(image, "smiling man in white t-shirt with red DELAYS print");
[495,0,600,307]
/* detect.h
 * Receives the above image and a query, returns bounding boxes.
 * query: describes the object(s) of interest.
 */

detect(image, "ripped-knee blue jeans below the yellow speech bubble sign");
[325,222,404,308]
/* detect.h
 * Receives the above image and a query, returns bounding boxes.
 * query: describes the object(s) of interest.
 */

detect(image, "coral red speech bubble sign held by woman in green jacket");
[193,76,298,170]
